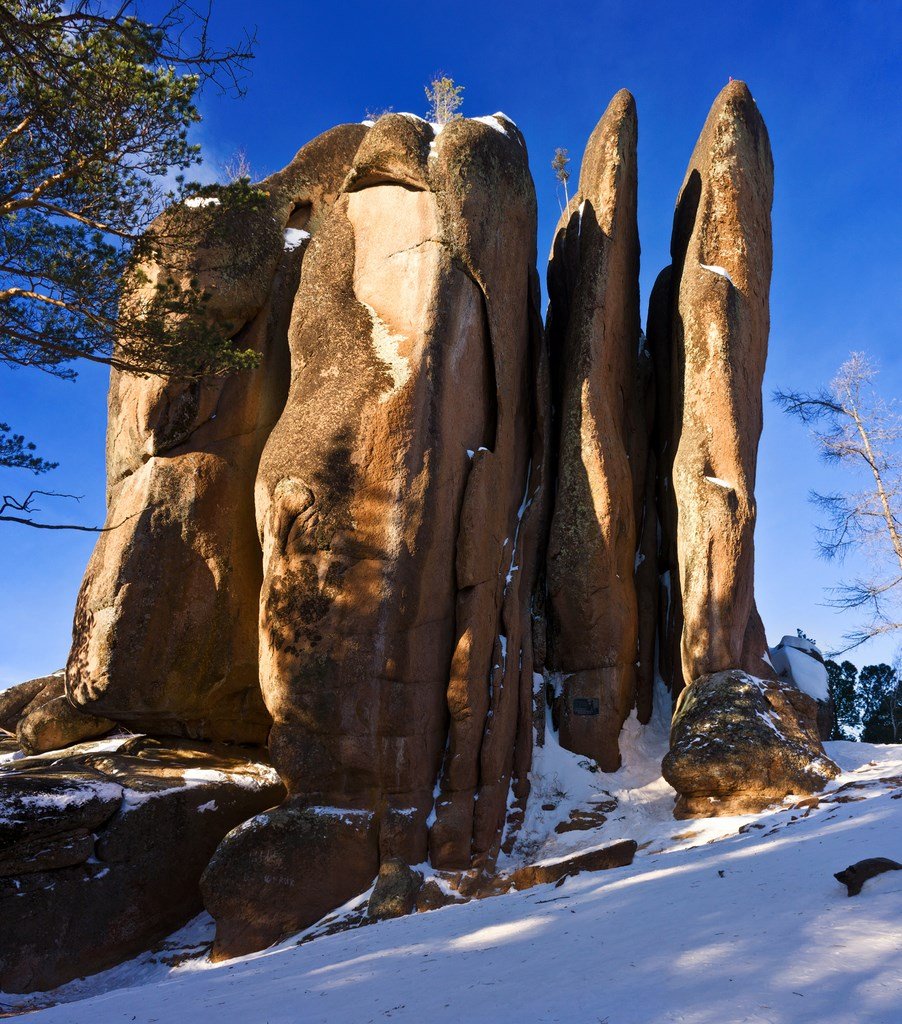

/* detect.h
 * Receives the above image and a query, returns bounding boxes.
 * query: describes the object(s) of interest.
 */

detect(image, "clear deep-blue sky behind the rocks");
[0,0,902,686]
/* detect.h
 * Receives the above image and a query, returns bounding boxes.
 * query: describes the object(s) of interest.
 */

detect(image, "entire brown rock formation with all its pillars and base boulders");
[0,82,836,987]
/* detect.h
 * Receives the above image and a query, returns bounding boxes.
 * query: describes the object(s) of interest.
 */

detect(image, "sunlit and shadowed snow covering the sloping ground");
[7,721,902,1024]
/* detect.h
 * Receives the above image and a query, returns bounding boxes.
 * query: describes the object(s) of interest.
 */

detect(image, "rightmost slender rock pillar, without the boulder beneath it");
[670,82,773,681]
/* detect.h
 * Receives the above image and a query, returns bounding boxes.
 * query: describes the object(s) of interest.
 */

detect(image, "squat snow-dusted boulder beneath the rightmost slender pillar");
[661,670,840,818]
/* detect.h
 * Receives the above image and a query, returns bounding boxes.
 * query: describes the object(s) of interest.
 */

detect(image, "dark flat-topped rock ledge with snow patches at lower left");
[0,737,285,992]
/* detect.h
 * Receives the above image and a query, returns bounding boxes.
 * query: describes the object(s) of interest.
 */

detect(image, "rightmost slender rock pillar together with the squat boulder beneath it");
[649,82,836,817]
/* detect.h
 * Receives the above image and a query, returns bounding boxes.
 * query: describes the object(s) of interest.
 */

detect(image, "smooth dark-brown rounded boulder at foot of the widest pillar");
[201,801,379,961]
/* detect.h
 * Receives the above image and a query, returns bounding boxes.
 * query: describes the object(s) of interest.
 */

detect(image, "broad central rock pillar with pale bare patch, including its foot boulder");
[205,115,547,955]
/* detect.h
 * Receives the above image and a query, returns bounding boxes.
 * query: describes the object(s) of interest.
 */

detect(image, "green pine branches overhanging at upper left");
[0,0,255,499]
